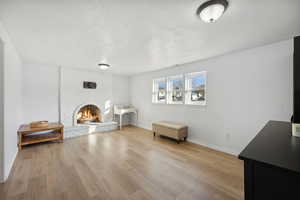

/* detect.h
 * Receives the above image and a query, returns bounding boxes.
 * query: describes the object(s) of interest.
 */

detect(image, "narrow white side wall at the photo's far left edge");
[0,23,22,181]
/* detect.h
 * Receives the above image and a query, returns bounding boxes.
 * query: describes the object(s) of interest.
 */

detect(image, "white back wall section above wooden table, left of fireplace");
[22,64,59,123]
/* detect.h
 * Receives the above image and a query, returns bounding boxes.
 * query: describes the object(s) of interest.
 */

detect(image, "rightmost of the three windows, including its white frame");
[185,71,206,105]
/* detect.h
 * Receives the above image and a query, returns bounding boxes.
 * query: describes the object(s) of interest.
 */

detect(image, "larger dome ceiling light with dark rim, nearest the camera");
[197,0,228,23]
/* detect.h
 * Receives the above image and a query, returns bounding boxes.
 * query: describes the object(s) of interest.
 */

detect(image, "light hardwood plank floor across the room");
[0,126,243,200]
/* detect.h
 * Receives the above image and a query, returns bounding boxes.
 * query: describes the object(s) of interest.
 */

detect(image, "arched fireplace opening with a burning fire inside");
[76,104,102,124]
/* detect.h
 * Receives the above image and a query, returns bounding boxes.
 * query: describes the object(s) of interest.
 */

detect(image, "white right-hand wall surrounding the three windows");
[130,40,293,154]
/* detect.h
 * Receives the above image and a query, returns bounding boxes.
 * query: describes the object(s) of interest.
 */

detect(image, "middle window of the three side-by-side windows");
[168,75,184,104]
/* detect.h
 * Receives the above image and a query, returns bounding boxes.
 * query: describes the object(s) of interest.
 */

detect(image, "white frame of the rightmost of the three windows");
[185,71,207,106]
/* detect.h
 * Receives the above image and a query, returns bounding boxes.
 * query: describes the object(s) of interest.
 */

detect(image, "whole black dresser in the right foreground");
[239,121,300,200]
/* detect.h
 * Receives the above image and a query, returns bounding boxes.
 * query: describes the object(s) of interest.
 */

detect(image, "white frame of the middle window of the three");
[167,74,185,104]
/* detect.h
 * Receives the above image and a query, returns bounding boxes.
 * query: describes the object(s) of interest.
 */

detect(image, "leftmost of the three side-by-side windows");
[152,78,167,103]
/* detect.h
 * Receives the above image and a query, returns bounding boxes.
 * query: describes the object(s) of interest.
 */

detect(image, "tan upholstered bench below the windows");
[152,121,188,143]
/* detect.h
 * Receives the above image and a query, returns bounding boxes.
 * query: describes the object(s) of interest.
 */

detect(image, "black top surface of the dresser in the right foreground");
[239,121,300,172]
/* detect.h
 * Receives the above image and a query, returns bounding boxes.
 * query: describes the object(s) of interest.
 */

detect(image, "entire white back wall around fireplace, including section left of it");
[23,64,129,127]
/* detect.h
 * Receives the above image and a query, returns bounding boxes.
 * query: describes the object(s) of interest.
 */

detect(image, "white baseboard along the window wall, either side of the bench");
[132,122,240,156]
